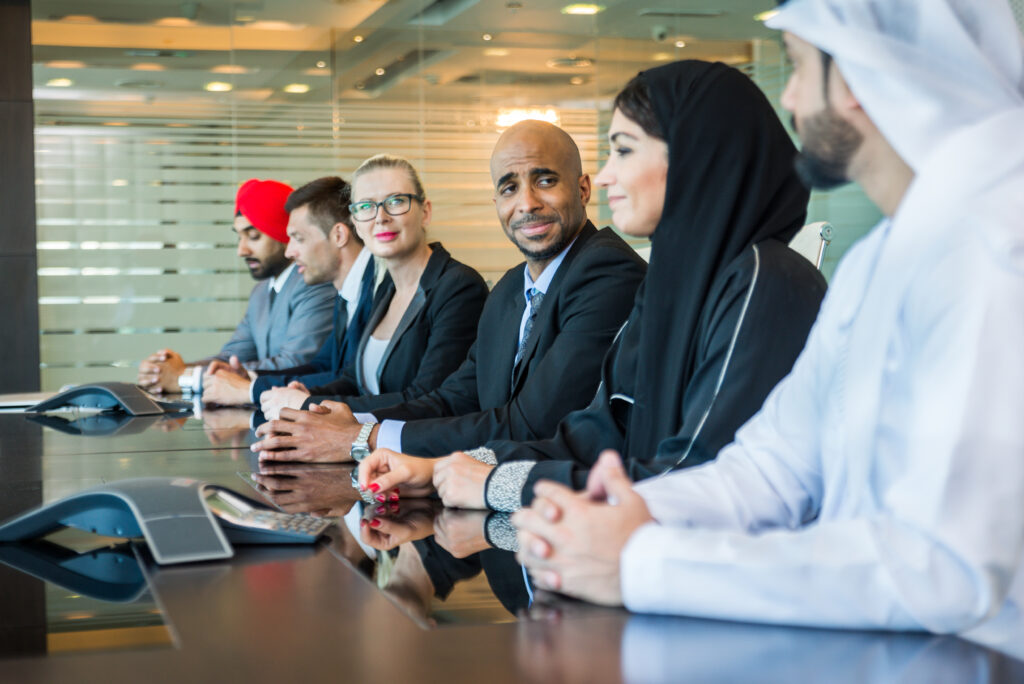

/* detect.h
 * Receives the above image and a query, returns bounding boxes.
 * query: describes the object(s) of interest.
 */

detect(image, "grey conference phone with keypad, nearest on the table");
[0,477,333,565]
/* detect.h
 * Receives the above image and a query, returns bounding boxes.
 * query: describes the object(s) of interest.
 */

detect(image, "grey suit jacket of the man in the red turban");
[216,268,338,371]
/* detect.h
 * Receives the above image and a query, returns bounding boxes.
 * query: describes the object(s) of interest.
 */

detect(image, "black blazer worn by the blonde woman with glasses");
[303,243,487,411]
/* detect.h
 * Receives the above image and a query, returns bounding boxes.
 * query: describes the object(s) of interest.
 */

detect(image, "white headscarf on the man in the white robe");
[767,0,1024,171]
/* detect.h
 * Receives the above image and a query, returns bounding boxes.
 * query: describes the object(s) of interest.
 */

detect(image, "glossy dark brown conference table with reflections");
[0,403,1024,684]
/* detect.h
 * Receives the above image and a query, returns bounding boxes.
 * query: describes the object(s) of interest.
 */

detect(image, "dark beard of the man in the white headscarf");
[793,108,864,190]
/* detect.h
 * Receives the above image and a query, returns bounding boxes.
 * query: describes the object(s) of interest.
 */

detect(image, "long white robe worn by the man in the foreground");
[622,112,1024,632]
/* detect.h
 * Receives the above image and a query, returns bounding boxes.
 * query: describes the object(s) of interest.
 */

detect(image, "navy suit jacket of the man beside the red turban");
[253,257,376,400]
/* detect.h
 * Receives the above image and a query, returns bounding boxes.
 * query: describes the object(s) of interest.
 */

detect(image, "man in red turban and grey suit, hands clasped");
[138,178,335,392]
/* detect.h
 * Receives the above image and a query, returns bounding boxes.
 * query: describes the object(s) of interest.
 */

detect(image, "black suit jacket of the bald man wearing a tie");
[364,221,647,456]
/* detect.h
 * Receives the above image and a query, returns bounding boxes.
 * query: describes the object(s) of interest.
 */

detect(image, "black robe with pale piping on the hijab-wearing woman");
[487,240,825,506]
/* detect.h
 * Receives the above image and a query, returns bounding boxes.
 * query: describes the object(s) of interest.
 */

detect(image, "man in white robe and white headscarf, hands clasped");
[513,0,1024,649]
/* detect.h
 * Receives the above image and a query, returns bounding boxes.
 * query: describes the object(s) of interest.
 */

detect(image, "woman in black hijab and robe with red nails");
[359,60,825,511]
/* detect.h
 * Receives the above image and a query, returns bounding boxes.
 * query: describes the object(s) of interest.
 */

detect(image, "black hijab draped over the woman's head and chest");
[624,60,809,458]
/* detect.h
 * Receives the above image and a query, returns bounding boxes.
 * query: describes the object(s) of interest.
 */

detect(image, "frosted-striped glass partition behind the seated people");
[33,0,878,390]
